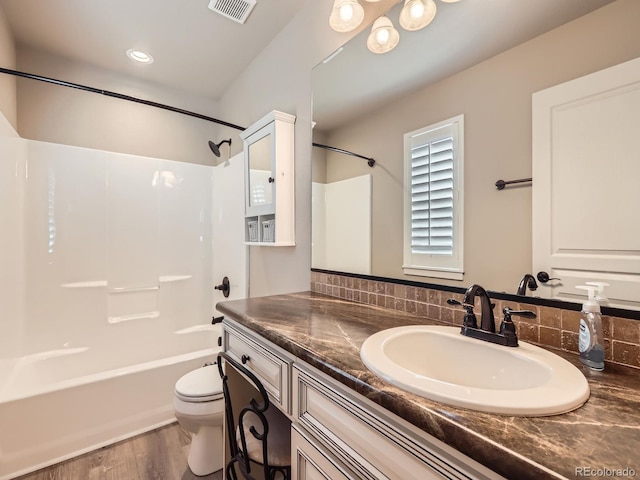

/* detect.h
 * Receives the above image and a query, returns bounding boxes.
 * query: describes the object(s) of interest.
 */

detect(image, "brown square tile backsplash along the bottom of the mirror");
[311,272,640,368]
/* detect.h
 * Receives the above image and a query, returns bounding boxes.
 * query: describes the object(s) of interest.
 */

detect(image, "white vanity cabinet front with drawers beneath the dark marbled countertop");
[224,319,502,480]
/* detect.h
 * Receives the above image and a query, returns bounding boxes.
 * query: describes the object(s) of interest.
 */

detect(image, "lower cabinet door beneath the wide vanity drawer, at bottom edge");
[291,426,358,480]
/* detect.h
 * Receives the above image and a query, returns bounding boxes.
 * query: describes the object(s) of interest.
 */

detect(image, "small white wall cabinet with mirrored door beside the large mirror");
[240,110,296,246]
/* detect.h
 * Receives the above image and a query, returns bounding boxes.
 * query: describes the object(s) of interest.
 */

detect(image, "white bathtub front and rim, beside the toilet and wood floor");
[0,342,216,480]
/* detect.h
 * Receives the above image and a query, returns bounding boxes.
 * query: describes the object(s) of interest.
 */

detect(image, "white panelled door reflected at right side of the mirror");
[533,58,640,308]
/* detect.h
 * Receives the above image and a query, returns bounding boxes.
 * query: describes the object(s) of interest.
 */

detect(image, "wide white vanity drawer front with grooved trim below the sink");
[292,363,496,480]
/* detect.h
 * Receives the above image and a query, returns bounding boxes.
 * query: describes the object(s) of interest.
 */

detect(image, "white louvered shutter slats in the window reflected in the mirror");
[411,137,454,255]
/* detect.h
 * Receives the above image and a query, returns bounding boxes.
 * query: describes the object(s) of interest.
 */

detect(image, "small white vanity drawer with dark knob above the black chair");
[223,321,292,414]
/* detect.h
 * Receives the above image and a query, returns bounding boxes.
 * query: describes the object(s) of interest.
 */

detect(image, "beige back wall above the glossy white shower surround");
[17,48,221,164]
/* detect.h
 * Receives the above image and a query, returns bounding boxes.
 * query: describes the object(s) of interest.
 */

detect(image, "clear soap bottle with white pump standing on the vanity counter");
[576,284,606,370]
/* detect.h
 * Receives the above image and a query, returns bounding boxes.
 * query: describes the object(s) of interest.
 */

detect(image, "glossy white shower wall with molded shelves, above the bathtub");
[0,117,213,360]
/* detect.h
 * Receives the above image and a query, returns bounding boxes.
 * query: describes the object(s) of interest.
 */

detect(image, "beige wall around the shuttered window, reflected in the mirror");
[327,0,640,293]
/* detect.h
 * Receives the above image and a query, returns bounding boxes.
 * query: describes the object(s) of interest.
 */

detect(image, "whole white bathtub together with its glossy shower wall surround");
[0,117,244,480]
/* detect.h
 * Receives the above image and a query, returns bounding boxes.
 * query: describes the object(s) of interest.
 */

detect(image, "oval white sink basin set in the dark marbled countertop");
[360,325,589,416]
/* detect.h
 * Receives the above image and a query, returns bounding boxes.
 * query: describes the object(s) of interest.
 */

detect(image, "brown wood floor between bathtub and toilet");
[16,423,222,480]
